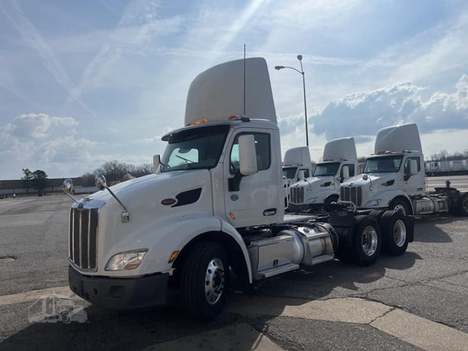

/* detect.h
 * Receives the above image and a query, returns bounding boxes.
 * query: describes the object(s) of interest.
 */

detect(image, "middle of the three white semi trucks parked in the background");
[289,138,358,211]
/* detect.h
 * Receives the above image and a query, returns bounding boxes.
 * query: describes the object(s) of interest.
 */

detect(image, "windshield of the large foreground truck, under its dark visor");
[161,125,229,172]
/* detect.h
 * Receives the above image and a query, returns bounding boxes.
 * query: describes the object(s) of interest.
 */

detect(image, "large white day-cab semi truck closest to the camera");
[66,58,413,318]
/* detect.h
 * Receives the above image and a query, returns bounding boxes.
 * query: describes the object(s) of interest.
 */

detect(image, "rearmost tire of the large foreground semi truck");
[381,211,411,256]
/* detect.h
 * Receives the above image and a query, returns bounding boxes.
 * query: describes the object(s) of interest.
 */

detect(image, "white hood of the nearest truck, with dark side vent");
[78,169,213,274]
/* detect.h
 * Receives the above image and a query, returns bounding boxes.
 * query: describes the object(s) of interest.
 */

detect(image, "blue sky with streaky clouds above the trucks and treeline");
[0,0,468,178]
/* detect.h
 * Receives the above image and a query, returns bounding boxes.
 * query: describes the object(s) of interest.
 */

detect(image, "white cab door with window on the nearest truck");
[224,129,284,228]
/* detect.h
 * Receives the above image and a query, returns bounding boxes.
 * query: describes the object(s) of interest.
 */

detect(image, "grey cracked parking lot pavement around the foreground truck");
[0,195,468,350]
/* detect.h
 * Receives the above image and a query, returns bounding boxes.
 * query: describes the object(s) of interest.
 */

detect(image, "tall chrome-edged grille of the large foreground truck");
[69,208,98,270]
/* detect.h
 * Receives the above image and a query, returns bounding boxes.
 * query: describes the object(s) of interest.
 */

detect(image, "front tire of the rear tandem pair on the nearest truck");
[352,216,382,266]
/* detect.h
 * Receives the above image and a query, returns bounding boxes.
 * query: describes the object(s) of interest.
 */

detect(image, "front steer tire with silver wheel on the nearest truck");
[180,242,229,320]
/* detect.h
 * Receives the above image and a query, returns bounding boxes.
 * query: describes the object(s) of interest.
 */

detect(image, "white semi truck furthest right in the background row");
[340,123,468,215]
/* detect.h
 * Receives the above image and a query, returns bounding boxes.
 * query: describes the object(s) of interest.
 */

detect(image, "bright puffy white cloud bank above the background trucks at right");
[311,75,468,139]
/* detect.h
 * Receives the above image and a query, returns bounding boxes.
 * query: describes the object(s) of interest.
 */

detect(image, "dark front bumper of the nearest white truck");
[68,266,169,309]
